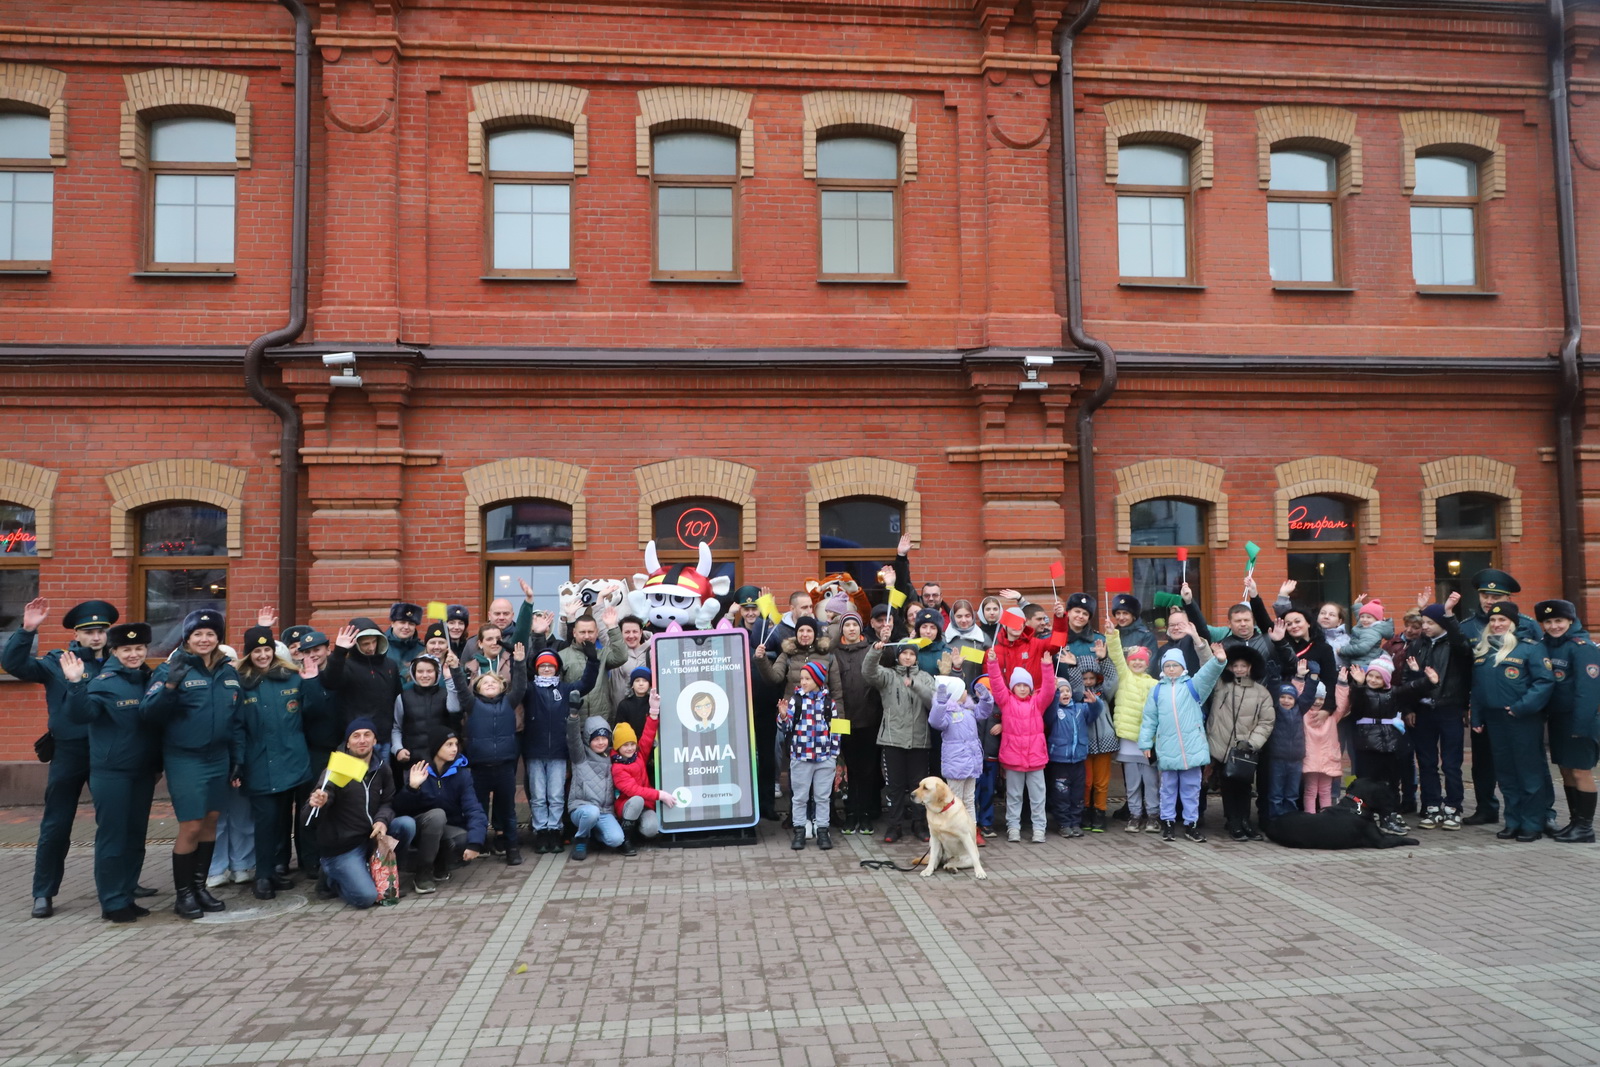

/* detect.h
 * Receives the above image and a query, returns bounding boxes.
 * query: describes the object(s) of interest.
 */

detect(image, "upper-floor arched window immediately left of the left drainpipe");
[146,118,238,272]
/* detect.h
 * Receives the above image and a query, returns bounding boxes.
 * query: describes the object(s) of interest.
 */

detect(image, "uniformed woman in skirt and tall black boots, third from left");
[139,609,245,918]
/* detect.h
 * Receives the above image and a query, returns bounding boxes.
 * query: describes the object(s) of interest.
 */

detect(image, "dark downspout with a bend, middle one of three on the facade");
[1056,0,1117,595]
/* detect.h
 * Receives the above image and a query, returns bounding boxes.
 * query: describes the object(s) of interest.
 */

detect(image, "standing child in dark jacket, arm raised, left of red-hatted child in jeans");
[454,645,528,867]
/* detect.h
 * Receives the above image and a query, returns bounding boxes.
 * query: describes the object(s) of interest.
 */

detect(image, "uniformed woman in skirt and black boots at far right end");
[1533,600,1600,845]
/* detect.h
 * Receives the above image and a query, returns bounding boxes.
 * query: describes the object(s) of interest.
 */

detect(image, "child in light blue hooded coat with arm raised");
[1139,645,1227,841]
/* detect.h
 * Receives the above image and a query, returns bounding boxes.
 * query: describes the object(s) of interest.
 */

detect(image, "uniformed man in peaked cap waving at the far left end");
[0,597,126,918]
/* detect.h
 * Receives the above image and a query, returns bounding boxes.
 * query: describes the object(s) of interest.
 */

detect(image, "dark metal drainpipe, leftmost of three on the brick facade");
[245,0,310,622]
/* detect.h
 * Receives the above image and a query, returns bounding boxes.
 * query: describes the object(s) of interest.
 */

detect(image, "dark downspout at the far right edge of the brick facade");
[1549,0,1586,606]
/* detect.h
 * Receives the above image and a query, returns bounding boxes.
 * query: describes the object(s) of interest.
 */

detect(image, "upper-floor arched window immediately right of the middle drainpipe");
[1117,144,1190,282]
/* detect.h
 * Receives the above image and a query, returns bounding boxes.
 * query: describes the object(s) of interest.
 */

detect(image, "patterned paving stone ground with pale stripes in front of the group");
[0,808,1600,1067]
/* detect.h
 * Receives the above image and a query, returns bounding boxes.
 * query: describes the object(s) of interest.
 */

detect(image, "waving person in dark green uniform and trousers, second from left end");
[61,622,162,923]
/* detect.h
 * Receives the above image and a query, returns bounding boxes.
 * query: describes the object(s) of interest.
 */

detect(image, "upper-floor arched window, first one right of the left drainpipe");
[486,126,573,278]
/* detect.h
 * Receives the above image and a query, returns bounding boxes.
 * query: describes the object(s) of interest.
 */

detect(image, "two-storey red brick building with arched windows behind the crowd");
[0,0,1600,760]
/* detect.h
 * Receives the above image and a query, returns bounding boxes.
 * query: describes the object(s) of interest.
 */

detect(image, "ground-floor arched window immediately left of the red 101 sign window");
[482,499,573,611]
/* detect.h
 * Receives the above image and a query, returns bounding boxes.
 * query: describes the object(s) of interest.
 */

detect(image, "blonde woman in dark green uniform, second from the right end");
[1472,600,1555,841]
